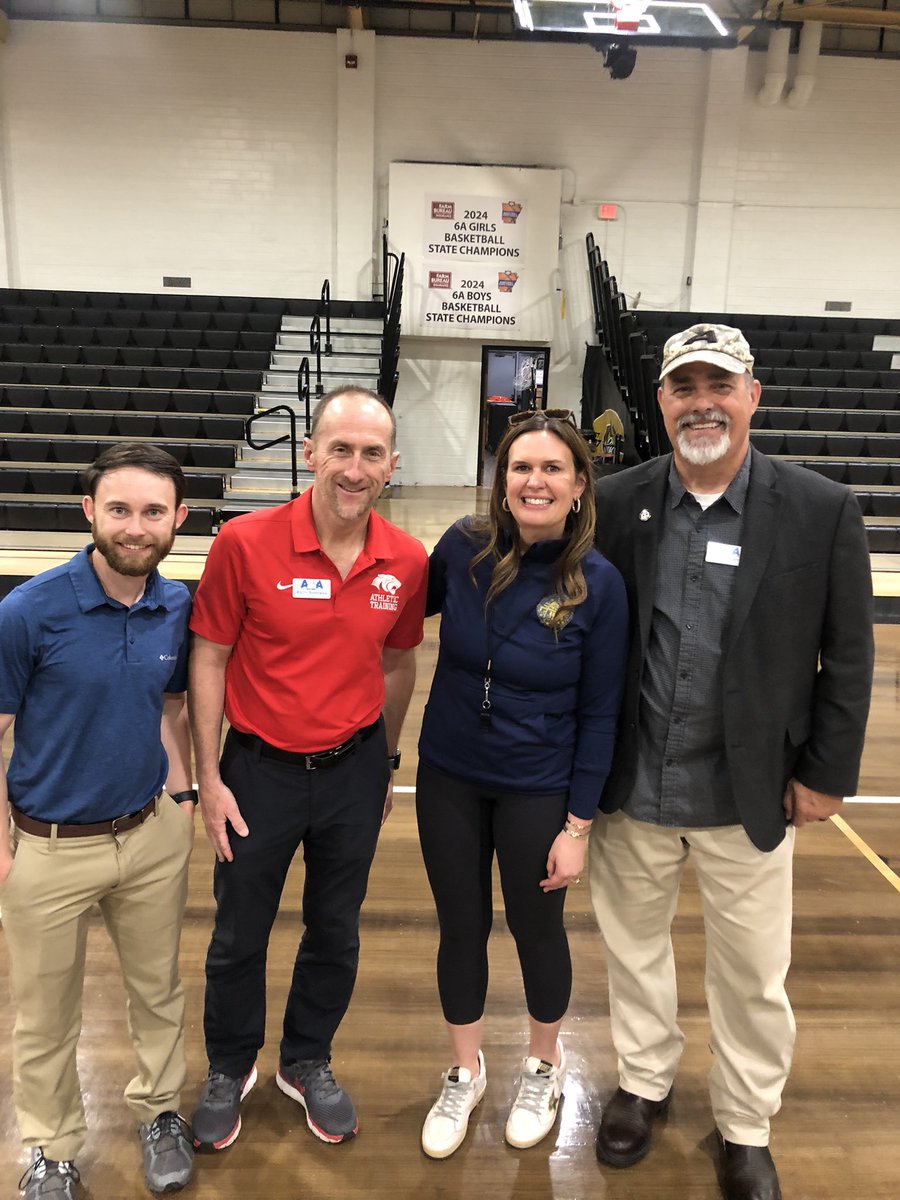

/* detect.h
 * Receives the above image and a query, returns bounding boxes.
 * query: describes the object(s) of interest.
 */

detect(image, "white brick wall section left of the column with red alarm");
[0,22,335,295]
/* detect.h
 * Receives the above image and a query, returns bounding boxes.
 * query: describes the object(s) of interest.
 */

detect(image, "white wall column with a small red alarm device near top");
[331,29,376,300]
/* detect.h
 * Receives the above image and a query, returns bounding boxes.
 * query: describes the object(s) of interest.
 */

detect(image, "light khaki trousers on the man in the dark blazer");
[589,812,794,1146]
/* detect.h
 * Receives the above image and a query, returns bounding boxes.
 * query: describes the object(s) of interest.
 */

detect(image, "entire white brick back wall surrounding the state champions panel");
[0,20,900,484]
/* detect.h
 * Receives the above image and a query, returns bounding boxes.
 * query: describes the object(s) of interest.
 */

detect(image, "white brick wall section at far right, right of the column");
[727,55,900,317]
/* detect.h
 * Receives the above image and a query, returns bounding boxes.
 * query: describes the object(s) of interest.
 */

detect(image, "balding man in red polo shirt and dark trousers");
[190,388,427,1150]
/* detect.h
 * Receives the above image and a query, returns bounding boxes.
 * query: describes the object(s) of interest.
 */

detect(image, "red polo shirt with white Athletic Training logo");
[191,488,427,752]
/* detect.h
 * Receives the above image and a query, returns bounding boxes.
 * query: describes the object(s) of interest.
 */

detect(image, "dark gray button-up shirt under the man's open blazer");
[625,452,750,828]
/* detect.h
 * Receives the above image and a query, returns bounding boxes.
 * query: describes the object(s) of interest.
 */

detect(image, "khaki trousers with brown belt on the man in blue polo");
[0,796,193,1159]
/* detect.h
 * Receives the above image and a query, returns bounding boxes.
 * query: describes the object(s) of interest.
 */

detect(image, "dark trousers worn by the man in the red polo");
[204,727,390,1078]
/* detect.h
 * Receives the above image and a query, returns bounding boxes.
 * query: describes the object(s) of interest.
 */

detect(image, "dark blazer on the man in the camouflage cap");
[596,450,874,851]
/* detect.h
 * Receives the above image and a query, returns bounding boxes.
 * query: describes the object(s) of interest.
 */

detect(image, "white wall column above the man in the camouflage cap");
[690,46,749,312]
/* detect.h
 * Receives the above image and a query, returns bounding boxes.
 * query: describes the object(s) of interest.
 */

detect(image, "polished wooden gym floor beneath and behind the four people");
[0,488,900,1200]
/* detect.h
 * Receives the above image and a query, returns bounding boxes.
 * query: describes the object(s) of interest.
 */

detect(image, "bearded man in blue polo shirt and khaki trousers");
[0,444,196,1200]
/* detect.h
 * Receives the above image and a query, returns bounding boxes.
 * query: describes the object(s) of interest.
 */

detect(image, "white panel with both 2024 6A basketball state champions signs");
[388,163,560,341]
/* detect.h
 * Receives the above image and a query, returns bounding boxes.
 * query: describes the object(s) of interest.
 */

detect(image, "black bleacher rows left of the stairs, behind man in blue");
[0,288,286,534]
